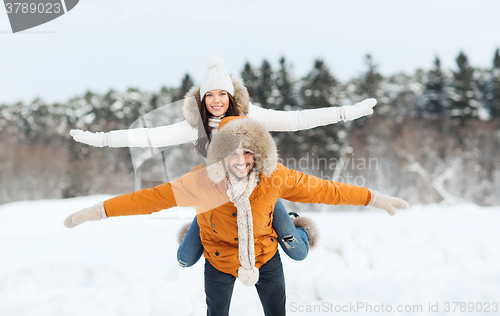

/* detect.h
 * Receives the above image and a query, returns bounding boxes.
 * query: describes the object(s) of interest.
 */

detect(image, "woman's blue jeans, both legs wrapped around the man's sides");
[177,200,309,267]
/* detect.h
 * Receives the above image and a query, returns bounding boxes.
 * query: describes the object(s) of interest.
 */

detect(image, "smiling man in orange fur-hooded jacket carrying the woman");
[65,116,408,315]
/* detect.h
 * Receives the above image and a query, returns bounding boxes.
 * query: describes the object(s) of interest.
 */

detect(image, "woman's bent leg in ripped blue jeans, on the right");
[273,200,309,261]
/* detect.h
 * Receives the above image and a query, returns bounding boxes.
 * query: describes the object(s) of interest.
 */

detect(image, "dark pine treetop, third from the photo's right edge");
[424,56,448,116]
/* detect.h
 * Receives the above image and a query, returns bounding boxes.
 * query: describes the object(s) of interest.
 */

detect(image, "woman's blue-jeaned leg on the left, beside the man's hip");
[177,216,203,268]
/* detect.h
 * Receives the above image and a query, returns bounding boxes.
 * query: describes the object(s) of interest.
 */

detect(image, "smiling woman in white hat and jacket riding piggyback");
[70,56,376,267]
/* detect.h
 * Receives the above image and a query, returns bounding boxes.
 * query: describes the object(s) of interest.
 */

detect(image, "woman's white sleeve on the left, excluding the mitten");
[109,121,198,148]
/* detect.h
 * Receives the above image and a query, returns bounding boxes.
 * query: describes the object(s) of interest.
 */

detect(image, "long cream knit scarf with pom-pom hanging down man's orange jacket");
[227,170,259,286]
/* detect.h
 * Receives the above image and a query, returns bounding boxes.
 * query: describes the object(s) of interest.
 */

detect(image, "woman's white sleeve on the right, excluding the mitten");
[248,103,341,132]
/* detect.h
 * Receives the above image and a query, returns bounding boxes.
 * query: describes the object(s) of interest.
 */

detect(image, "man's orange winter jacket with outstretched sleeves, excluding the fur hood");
[104,164,371,277]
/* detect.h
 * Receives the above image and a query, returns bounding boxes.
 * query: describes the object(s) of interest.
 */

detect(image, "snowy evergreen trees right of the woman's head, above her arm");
[241,49,500,121]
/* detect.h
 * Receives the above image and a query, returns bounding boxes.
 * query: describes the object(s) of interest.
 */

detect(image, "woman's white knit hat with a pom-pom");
[200,56,234,99]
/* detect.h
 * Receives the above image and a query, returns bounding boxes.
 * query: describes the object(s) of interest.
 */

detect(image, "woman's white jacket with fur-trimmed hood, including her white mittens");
[70,77,377,148]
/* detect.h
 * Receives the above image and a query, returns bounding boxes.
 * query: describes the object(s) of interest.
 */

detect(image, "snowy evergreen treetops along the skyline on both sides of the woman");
[0,49,500,143]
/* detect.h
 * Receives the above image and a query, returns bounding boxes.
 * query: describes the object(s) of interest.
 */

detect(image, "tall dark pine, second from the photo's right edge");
[451,52,478,124]
